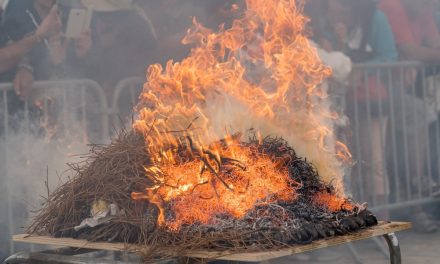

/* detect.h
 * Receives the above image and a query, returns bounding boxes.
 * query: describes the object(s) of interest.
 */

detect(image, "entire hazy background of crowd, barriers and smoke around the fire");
[0,0,440,263]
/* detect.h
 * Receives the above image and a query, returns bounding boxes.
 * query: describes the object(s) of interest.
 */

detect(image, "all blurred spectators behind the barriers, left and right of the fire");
[0,0,440,237]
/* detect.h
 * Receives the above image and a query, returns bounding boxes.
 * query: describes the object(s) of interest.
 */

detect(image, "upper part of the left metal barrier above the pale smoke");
[0,80,109,141]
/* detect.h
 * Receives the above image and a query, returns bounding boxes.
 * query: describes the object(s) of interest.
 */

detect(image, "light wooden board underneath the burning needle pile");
[12,222,411,262]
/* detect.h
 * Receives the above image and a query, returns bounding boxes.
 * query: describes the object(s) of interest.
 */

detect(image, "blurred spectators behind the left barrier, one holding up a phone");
[0,0,237,99]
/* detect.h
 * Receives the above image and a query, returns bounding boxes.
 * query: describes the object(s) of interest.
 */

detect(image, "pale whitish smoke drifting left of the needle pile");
[0,96,94,257]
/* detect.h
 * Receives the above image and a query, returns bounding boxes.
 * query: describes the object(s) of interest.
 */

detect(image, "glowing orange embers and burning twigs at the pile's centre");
[132,135,300,230]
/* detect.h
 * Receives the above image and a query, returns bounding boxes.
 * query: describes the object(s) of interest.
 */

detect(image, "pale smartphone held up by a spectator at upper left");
[64,8,92,38]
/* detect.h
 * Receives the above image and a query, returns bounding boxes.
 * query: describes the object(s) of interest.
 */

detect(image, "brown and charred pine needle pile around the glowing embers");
[28,132,377,259]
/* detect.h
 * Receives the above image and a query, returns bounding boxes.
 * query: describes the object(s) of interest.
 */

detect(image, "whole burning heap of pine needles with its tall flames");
[30,0,377,260]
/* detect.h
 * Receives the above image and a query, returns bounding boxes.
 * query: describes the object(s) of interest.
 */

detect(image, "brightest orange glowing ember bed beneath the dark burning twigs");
[133,137,298,229]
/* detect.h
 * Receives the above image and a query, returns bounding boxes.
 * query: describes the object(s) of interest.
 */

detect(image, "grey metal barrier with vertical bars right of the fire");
[345,62,440,210]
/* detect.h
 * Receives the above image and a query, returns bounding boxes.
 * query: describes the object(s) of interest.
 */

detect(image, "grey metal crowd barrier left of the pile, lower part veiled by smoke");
[0,80,109,257]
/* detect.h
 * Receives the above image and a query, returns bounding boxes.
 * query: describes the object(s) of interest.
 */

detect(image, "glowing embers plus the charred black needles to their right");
[132,135,375,236]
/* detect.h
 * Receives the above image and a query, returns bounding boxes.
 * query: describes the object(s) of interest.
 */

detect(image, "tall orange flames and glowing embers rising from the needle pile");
[132,0,349,230]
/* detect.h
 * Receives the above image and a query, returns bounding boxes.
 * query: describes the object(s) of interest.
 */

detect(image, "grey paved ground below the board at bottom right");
[271,231,440,264]
